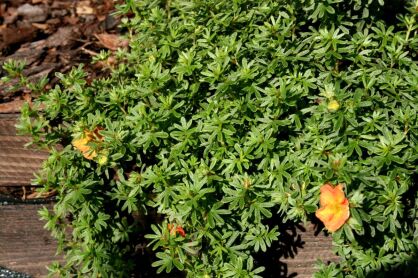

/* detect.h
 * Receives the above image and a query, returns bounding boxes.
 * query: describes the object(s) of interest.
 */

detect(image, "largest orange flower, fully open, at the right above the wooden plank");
[315,183,350,232]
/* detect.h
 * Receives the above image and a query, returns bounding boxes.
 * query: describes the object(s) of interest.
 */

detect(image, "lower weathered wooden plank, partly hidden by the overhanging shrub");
[0,204,338,278]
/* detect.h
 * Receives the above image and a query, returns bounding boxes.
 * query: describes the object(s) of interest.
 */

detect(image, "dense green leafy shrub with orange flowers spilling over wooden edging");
[5,0,418,277]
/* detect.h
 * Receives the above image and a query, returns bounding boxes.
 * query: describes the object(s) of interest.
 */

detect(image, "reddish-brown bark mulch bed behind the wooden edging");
[0,0,127,113]
